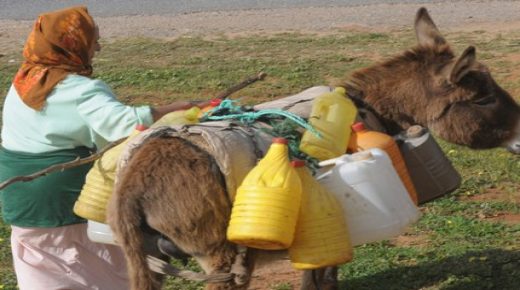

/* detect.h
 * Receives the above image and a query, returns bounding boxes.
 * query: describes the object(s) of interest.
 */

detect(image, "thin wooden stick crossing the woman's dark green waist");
[0,137,126,190]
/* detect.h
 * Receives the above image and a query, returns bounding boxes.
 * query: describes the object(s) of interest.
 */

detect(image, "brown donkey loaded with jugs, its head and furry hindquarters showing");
[105,9,520,290]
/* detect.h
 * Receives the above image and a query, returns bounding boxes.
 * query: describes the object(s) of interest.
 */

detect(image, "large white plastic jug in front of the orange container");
[318,148,420,246]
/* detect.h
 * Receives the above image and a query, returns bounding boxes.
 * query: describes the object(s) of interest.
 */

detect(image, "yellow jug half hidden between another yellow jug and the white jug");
[289,161,353,270]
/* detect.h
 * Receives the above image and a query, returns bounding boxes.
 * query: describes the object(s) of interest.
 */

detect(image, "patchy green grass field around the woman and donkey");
[0,27,520,290]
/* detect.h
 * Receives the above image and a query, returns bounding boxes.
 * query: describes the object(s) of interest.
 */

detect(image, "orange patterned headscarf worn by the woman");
[13,6,97,110]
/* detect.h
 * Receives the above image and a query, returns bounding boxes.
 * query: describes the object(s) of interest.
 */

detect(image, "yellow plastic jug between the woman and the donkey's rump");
[73,125,146,223]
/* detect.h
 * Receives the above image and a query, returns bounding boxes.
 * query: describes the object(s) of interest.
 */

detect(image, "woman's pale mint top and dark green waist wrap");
[0,75,153,227]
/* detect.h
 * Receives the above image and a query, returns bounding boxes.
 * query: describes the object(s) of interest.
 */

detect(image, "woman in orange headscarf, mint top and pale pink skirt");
[0,7,207,290]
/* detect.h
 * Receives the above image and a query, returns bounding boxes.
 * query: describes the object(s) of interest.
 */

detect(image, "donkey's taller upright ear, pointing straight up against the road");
[415,7,446,47]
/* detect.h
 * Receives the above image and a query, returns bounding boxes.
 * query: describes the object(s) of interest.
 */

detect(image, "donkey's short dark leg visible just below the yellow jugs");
[300,267,338,290]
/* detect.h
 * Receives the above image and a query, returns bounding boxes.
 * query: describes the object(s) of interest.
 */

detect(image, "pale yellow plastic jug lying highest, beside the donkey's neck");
[300,87,357,161]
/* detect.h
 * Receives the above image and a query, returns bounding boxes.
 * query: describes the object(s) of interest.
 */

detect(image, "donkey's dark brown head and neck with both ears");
[347,8,520,153]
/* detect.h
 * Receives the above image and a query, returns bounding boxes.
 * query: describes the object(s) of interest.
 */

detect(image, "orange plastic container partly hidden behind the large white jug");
[347,122,418,205]
